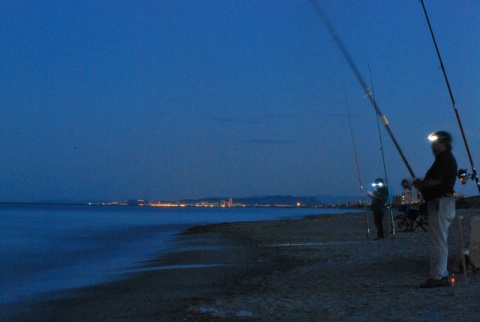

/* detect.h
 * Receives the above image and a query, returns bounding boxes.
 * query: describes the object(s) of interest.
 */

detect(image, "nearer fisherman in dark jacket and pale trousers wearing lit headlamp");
[413,131,457,288]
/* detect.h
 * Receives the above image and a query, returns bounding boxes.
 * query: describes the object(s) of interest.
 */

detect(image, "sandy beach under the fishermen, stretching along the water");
[4,209,480,321]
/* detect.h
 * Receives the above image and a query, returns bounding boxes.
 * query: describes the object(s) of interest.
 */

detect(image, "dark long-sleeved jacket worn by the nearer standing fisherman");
[421,151,457,201]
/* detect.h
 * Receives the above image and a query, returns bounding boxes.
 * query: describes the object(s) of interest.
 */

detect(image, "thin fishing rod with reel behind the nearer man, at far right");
[420,0,480,193]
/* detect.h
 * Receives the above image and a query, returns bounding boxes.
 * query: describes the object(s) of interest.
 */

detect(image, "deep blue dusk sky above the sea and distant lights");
[0,0,480,201]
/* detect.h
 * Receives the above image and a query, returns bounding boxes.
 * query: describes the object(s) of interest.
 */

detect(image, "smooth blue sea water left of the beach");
[0,205,352,304]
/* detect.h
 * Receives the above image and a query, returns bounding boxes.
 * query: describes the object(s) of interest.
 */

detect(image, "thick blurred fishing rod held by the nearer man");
[313,0,416,178]
